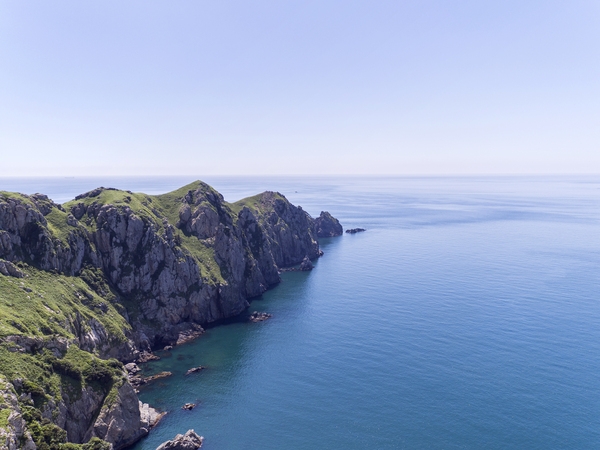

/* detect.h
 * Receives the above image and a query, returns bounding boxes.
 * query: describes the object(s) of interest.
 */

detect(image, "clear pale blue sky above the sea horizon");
[0,0,600,177]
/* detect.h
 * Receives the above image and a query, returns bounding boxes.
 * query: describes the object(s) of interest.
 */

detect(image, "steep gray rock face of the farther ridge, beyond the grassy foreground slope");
[0,183,337,346]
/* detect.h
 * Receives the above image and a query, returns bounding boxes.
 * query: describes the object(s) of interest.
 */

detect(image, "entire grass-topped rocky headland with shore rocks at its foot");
[0,181,343,450]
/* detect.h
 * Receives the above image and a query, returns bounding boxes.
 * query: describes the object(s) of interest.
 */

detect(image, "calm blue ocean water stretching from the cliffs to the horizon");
[0,177,600,450]
